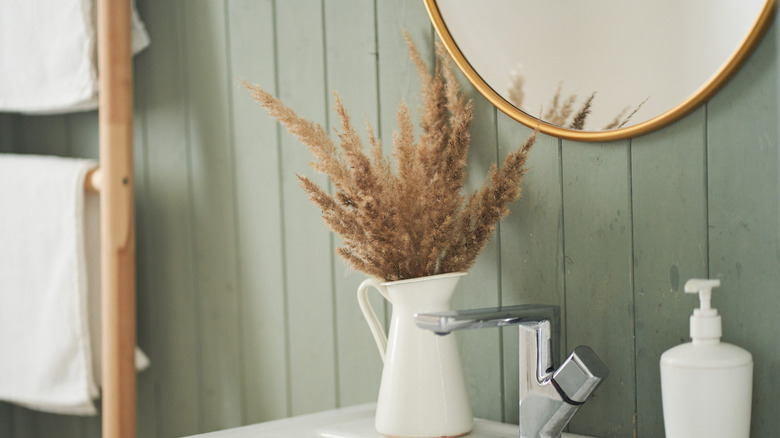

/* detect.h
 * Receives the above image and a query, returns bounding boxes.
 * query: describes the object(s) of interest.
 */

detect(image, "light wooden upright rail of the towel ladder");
[96,0,136,438]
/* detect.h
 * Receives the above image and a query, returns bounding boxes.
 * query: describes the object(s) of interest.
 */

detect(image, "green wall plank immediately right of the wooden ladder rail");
[136,1,206,437]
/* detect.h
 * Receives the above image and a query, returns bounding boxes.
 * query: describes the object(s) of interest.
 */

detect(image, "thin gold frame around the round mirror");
[424,0,776,142]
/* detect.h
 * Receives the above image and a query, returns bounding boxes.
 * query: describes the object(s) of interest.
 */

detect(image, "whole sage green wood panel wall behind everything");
[0,0,780,438]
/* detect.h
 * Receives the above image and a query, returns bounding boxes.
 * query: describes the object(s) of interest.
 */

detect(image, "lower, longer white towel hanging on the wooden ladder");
[0,154,148,415]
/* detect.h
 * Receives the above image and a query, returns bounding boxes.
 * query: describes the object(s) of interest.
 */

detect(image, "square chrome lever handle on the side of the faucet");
[551,345,609,406]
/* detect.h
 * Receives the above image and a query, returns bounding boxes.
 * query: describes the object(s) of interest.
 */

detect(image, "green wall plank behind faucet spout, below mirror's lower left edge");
[498,120,565,424]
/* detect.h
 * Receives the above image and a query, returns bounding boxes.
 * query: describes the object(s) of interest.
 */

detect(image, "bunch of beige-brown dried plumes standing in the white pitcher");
[244,33,536,281]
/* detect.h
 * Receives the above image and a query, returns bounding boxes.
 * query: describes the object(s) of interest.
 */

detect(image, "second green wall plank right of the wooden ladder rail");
[181,0,244,430]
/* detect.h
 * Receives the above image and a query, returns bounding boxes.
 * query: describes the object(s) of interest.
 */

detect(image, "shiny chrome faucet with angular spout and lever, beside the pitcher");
[415,304,609,438]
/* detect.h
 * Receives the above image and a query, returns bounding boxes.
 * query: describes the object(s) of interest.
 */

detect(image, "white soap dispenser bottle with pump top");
[661,279,753,438]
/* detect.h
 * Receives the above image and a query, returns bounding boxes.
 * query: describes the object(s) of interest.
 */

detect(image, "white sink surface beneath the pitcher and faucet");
[184,403,588,438]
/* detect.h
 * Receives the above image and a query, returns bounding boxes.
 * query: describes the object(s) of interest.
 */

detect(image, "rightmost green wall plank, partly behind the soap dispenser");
[707,26,780,436]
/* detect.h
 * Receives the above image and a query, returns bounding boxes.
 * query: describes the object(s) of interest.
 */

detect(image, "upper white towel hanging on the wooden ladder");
[0,0,149,113]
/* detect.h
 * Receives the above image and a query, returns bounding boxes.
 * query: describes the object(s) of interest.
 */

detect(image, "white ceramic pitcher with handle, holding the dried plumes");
[357,272,473,438]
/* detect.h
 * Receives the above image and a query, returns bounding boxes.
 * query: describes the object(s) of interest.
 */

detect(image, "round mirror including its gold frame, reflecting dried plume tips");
[425,0,775,141]
